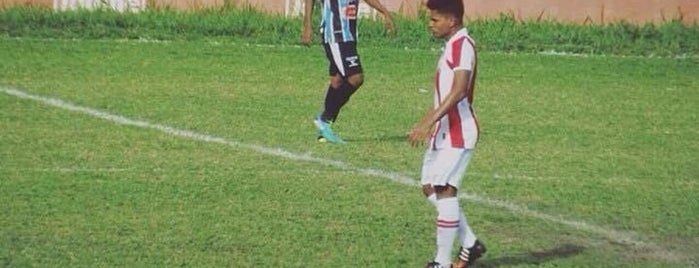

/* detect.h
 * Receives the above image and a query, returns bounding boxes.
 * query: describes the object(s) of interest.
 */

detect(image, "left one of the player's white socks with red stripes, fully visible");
[434,197,460,267]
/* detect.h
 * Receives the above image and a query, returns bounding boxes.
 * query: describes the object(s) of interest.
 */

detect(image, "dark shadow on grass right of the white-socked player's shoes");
[474,244,585,267]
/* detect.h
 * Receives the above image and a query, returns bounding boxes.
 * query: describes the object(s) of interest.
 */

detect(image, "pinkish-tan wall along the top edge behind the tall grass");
[0,0,699,24]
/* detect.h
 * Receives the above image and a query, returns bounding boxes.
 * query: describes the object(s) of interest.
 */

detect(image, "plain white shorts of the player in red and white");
[421,148,473,189]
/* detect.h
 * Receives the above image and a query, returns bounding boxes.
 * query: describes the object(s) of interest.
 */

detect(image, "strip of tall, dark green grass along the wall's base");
[0,5,699,56]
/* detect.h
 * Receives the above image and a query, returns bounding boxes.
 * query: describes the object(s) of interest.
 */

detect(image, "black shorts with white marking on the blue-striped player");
[323,42,362,77]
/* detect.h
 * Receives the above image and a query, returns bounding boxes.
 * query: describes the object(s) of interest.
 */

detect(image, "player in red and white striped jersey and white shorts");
[408,0,486,268]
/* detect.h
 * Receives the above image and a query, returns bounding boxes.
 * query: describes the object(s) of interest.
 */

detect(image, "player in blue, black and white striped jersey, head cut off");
[301,0,395,143]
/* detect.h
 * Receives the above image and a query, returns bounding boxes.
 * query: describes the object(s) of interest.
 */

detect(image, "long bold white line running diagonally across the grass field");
[0,86,684,260]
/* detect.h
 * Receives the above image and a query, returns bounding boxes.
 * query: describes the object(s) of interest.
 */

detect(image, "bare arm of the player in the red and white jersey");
[408,70,471,146]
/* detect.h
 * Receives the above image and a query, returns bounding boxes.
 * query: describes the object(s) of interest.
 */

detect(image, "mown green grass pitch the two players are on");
[0,38,699,267]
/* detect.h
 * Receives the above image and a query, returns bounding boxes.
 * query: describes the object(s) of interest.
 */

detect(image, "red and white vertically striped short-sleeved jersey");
[430,28,478,149]
